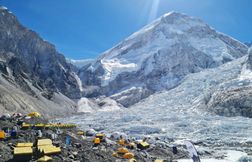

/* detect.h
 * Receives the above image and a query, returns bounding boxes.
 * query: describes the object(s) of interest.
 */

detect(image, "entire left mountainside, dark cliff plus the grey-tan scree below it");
[0,7,80,114]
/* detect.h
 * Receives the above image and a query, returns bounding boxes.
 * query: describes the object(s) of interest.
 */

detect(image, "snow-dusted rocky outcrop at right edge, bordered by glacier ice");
[208,49,252,118]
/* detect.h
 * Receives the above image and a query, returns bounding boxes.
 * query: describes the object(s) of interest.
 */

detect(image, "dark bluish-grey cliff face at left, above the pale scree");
[0,9,80,99]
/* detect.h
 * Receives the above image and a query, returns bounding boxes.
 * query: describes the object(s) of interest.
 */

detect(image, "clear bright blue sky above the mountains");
[0,0,252,59]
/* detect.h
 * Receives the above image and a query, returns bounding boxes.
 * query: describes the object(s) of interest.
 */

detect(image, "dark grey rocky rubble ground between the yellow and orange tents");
[0,114,188,162]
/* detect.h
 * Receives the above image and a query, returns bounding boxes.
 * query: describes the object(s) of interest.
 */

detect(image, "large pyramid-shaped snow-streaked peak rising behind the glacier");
[79,12,247,107]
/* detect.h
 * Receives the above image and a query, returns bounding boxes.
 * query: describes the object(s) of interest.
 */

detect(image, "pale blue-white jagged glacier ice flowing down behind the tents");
[59,56,252,160]
